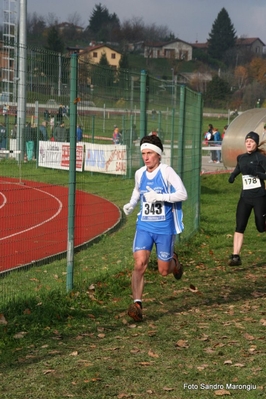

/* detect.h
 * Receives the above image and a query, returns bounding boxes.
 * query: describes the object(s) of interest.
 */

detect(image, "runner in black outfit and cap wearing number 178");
[228,132,266,266]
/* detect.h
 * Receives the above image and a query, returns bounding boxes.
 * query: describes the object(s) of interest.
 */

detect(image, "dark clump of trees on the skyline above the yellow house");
[27,3,175,50]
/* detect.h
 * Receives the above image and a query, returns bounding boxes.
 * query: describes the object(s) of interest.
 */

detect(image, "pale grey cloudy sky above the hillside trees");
[24,0,266,44]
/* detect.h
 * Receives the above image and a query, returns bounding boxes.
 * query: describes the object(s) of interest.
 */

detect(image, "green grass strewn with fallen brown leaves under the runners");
[0,174,266,399]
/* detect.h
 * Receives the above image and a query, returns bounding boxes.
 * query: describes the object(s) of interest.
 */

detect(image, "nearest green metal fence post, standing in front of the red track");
[66,53,78,291]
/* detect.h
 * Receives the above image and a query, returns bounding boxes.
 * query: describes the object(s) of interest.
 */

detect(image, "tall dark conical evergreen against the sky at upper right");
[208,8,236,60]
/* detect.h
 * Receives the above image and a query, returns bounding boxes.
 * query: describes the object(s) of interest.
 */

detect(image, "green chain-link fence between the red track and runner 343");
[0,43,202,302]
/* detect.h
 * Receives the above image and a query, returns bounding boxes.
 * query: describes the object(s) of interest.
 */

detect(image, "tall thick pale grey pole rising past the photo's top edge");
[17,0,27,161]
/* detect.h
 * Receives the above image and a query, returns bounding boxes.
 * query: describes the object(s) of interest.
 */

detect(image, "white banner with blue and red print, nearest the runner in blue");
[84,143,127,175]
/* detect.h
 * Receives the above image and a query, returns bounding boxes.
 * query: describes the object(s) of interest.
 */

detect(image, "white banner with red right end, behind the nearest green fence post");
[38,141,84,172]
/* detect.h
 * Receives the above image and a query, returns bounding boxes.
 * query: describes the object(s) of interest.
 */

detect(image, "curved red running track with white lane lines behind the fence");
[0,178,121,273]
